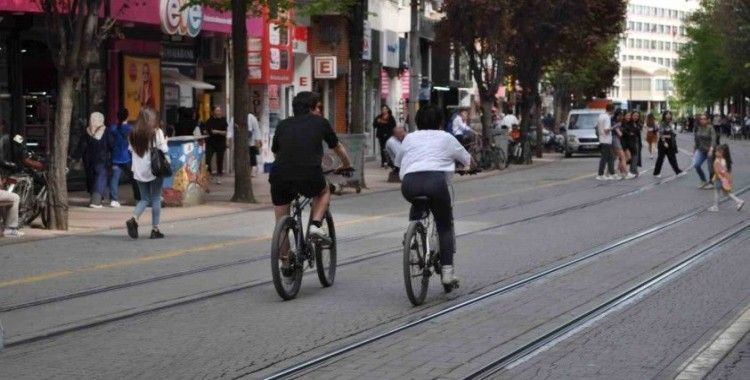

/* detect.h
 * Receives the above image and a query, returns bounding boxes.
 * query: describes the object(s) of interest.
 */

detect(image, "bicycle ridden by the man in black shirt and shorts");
[271,169,352,301]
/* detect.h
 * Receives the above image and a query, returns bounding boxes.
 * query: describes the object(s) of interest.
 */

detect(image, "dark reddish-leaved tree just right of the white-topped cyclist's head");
[438,0,516,138]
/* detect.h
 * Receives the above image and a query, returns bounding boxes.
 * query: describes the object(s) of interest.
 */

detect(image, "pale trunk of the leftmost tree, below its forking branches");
[47,74,76,231]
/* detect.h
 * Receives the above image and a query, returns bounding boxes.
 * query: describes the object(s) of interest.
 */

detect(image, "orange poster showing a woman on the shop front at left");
[122,55,161,120]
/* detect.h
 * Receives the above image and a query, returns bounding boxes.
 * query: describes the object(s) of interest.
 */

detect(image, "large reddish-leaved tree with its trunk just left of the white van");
[508,0,626,162]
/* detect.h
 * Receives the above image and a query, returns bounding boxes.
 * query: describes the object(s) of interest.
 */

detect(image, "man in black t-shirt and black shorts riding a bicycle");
[268,91,352,240]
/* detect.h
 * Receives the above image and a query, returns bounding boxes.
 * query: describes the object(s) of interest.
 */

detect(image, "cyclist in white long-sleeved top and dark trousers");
[396,106,472,285]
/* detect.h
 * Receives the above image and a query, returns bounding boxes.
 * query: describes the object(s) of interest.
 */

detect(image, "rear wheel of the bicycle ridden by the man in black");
[271,216,304,301]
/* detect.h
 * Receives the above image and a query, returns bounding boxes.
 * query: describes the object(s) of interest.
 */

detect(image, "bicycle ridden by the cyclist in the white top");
[402,170,480,306]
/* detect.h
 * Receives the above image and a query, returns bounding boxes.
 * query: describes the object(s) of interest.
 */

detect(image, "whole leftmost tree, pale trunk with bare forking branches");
[38,0,122,230]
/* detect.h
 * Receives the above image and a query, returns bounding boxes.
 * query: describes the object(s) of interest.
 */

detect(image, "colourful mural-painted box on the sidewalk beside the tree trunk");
[162,139,208,206]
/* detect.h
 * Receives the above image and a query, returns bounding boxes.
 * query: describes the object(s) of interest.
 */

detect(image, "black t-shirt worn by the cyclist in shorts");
[269,114,339,181]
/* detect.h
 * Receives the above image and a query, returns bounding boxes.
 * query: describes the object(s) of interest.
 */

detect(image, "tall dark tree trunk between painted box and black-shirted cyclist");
[229,0,255,203]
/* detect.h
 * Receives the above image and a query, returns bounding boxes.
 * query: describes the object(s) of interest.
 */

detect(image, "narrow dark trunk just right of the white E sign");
[349,0,367,134]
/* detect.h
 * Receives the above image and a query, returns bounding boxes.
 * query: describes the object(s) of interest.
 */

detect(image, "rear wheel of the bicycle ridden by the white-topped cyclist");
[403,221,430,306]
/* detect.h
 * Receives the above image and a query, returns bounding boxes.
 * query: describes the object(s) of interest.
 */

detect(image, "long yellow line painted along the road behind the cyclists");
[0,169,593,288]
